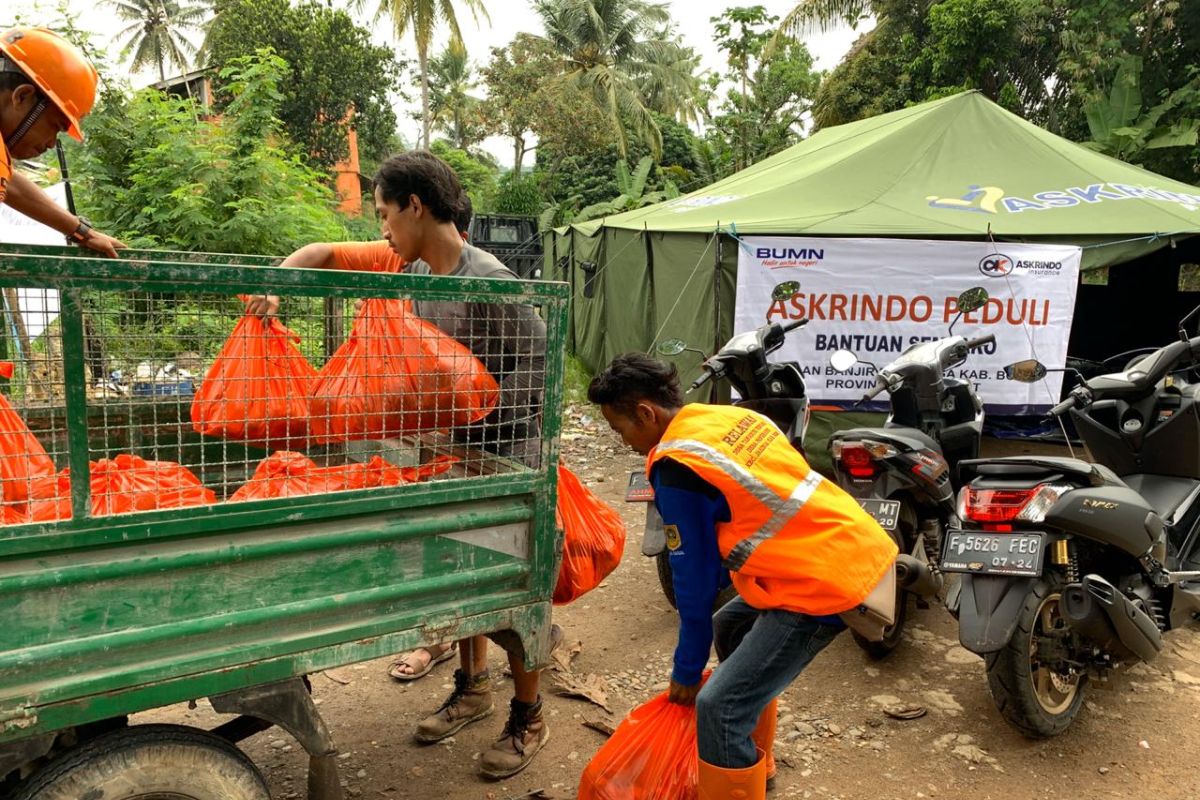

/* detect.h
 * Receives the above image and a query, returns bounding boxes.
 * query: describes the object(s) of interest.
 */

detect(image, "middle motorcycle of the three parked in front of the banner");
[829,287,996,658]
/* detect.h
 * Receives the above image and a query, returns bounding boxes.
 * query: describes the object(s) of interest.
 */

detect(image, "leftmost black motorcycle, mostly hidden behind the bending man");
[625,309,809,608]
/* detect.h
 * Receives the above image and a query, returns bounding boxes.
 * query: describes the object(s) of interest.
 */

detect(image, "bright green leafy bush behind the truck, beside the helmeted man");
[77,52,346,254]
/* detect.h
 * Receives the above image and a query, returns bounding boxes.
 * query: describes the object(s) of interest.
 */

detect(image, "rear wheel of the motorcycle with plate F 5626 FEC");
[985,575,1087,739]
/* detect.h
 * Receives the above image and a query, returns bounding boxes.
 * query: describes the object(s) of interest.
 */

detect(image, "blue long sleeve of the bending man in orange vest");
[650,458,730,686]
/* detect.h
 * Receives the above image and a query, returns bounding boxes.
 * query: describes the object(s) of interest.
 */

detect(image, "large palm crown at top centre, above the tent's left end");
[534,0,695,155]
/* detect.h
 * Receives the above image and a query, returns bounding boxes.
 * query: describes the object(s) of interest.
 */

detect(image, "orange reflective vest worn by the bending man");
[646,403,898,615]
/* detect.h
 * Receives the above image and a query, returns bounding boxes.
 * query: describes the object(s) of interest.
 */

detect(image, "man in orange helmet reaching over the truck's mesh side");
[0,28,125,257]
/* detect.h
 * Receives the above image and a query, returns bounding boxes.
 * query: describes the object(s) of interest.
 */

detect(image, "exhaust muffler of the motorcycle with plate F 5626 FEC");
[1062,575,1163,661]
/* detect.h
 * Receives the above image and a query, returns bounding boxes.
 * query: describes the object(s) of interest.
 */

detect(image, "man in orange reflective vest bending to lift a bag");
[588,353,896,800]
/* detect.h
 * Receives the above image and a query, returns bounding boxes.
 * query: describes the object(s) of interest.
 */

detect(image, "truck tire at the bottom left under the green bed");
[13,724,271,800]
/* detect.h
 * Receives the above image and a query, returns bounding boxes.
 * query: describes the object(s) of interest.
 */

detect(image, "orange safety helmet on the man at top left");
[0,28,100,142]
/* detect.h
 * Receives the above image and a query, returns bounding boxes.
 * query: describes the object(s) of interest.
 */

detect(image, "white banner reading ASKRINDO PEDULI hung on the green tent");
[734,236,1082,414]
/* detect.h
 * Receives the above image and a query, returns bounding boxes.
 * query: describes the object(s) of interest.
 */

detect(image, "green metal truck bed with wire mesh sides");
[0,246,568,800]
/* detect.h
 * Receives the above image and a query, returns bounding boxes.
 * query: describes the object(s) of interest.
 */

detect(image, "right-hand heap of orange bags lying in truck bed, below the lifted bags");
[229,451,458,503]
